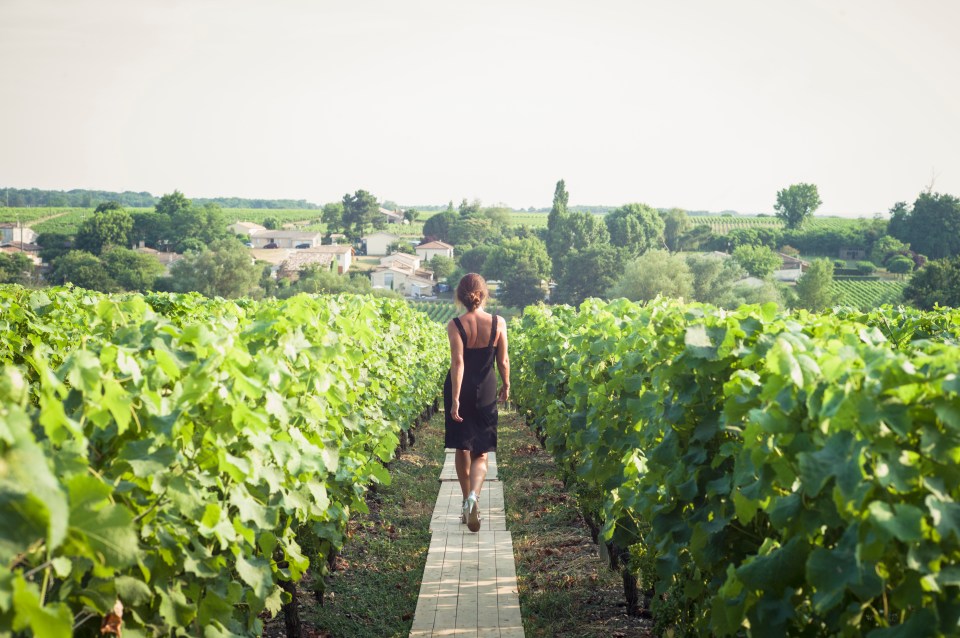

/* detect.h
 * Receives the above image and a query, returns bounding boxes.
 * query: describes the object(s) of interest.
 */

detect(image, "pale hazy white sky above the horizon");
[0,0,960,215]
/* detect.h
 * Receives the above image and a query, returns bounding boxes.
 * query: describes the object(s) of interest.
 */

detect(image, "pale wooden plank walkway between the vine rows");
[410,450,523,638]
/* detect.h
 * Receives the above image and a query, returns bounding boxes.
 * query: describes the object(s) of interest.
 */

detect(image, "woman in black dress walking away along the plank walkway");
[443,273,510,532]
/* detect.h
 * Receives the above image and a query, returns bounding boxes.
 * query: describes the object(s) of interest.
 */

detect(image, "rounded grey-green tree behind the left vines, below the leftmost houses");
[169,239,261,299]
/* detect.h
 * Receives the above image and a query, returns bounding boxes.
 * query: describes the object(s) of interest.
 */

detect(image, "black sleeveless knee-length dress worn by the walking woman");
[443,315,498,454]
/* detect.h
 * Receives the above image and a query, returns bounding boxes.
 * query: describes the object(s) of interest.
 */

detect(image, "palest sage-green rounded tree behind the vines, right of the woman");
[610,249,693,301]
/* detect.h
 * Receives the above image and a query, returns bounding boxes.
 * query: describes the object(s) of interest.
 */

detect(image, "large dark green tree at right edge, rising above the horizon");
[888,193,960,259]
